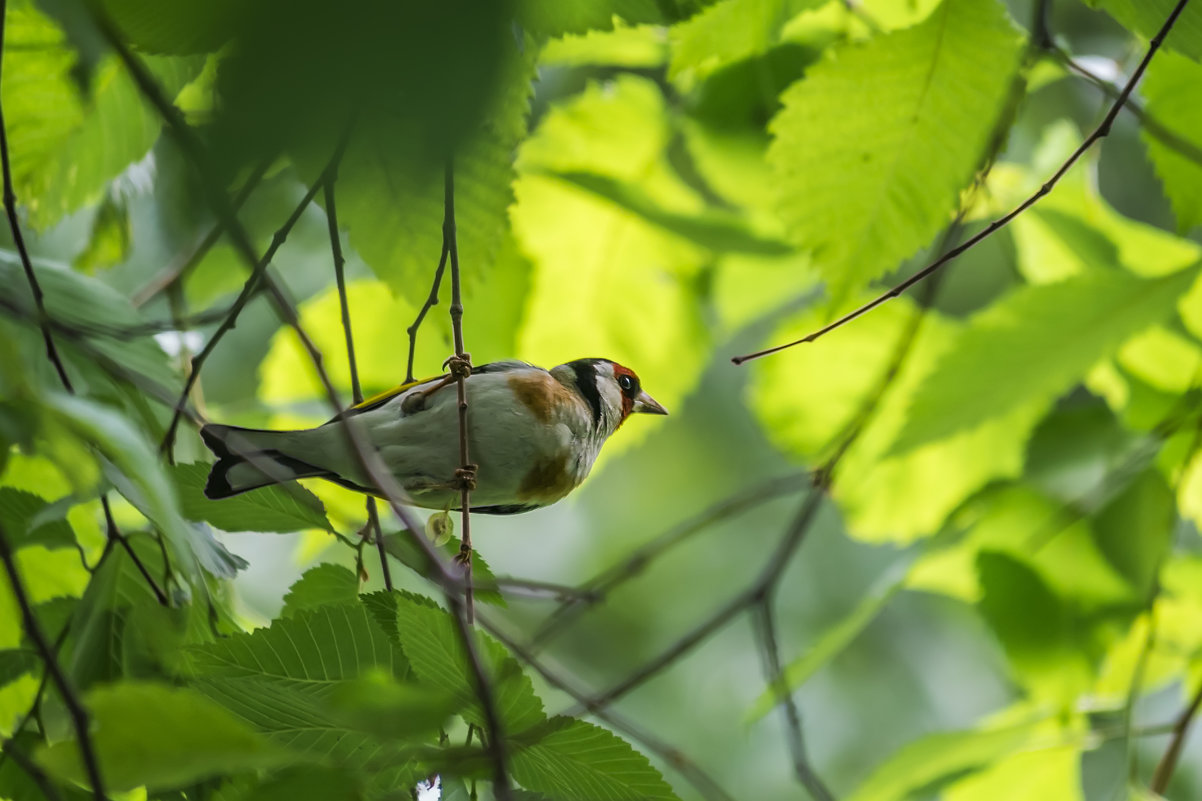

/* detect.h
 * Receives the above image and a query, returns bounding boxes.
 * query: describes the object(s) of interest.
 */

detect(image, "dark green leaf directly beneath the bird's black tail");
[172,463,334,532]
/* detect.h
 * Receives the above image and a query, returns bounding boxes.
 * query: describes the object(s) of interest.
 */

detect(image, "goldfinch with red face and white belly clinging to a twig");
[201,358,667,515]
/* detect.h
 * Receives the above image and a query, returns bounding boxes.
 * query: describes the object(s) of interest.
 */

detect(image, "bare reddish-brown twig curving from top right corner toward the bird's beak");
[731,0,1189,364]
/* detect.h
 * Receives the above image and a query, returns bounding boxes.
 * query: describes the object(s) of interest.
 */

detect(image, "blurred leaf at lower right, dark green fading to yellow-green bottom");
[977,551,1093,705]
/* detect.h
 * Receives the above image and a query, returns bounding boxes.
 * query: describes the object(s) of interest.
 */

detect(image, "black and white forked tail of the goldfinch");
[201,425,331,499]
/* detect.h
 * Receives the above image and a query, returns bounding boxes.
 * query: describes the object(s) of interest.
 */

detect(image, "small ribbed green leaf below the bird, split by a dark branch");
[384,593,545,737]
